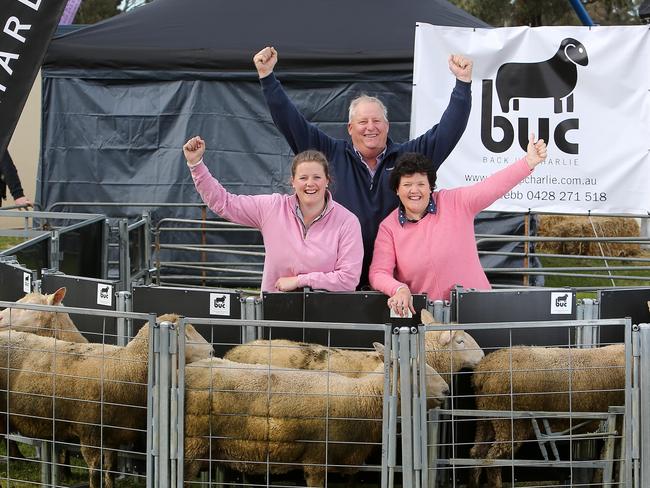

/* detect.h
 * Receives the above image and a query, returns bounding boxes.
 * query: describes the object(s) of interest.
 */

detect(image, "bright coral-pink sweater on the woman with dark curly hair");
[369,158,531,300]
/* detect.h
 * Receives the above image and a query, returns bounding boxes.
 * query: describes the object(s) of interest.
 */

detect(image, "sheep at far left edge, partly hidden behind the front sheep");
[0,287,88,343]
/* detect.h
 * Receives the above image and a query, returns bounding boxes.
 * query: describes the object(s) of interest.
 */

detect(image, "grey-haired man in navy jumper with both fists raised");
[253,47,472,286]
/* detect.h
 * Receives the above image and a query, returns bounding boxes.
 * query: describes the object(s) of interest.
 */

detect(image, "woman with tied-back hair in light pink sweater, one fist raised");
[183,136,363,291]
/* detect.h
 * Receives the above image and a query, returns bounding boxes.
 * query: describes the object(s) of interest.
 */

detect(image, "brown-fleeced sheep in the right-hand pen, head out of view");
[470,344,625,488]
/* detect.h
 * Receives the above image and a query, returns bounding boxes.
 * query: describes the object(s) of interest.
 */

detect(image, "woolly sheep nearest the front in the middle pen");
[185,343,448,487]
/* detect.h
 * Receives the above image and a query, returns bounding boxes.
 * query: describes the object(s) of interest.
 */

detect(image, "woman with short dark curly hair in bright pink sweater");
[369,134,546,316]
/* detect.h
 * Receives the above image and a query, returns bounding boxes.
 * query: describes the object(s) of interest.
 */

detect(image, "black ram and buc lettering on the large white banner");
[481,37,589,154]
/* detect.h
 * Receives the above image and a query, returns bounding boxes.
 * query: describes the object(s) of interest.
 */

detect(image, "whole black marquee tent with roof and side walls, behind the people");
[37,0,536,286]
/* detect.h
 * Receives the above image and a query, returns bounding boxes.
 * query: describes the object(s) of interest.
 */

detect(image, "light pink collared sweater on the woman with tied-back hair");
[190,163,363,291]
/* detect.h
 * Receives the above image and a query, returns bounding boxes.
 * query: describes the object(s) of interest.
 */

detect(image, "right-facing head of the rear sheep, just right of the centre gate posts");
[420,309,485,373]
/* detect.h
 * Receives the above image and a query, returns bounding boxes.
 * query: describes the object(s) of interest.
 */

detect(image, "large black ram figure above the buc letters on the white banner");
[495,37,589,114]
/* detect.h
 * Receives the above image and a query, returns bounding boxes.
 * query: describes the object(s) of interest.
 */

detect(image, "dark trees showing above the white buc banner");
[451,0,641,27]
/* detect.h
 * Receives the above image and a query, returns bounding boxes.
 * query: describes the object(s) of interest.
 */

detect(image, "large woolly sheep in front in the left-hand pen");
[0,315,212,488]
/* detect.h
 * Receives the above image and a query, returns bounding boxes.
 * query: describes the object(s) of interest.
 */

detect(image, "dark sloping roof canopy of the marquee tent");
[46,0,488,74]
